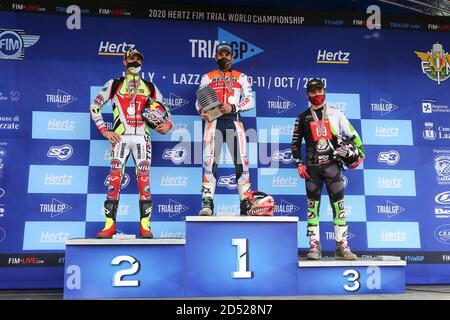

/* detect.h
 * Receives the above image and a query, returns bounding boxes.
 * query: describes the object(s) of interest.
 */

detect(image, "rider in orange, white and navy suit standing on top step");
[195,43,255,216]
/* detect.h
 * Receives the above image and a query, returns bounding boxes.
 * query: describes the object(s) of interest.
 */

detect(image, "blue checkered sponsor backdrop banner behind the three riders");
[0,7,450,288]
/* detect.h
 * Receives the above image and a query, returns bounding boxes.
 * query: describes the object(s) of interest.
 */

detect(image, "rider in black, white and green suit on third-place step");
[291,79,365,260]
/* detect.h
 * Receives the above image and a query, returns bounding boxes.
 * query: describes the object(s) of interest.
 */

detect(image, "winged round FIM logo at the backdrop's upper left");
[0,29,40,60]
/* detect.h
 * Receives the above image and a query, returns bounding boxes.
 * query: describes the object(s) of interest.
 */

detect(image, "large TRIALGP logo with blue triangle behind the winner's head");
[188,28,264,63]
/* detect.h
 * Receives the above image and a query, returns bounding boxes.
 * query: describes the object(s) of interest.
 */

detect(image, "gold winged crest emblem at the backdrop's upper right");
[414,43,450,85]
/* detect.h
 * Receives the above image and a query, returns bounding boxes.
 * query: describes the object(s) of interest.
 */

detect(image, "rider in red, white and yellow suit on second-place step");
[90,50,173,238]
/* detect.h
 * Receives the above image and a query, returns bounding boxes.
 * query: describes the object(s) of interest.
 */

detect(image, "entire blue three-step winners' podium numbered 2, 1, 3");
[64,216,406,299]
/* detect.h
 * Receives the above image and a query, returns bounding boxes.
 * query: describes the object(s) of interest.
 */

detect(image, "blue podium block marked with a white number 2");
[64,239,185,299]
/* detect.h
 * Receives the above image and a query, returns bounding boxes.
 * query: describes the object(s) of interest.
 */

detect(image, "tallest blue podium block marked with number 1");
[185,216,298,297]
